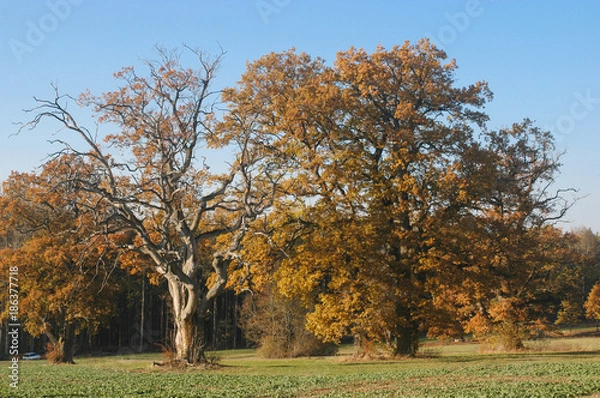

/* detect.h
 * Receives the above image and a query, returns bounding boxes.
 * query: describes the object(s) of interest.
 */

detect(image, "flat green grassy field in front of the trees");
[0,337,600,398]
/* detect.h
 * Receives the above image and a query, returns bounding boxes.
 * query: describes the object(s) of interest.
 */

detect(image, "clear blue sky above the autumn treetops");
[0,0,600,232]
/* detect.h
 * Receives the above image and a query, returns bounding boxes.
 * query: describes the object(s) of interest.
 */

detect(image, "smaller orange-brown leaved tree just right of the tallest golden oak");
[424,120,572,350]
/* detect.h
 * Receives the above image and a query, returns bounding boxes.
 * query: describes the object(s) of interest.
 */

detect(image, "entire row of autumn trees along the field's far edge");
[0,40,600,363]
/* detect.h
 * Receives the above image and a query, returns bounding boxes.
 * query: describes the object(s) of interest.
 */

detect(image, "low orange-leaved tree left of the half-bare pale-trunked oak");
[0,158,119,363]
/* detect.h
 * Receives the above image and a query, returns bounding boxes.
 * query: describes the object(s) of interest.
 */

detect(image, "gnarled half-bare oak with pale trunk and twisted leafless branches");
[21,48,278,363]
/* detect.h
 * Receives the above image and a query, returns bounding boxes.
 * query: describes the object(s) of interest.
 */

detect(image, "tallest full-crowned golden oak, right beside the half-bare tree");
[225,41,491,354]
